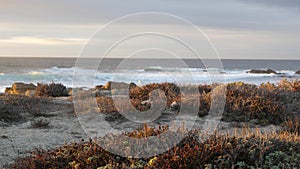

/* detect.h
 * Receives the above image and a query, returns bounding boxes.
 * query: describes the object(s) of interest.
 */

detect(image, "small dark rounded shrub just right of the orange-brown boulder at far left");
[35,83,69,97]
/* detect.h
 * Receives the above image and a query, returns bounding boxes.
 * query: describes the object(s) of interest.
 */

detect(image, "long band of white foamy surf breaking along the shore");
[0,67,299,92]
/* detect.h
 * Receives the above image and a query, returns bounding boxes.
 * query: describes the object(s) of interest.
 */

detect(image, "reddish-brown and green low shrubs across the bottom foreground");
[10,126,300,169]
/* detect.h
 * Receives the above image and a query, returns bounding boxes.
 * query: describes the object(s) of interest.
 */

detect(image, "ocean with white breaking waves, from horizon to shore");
[0,57,300,92]
